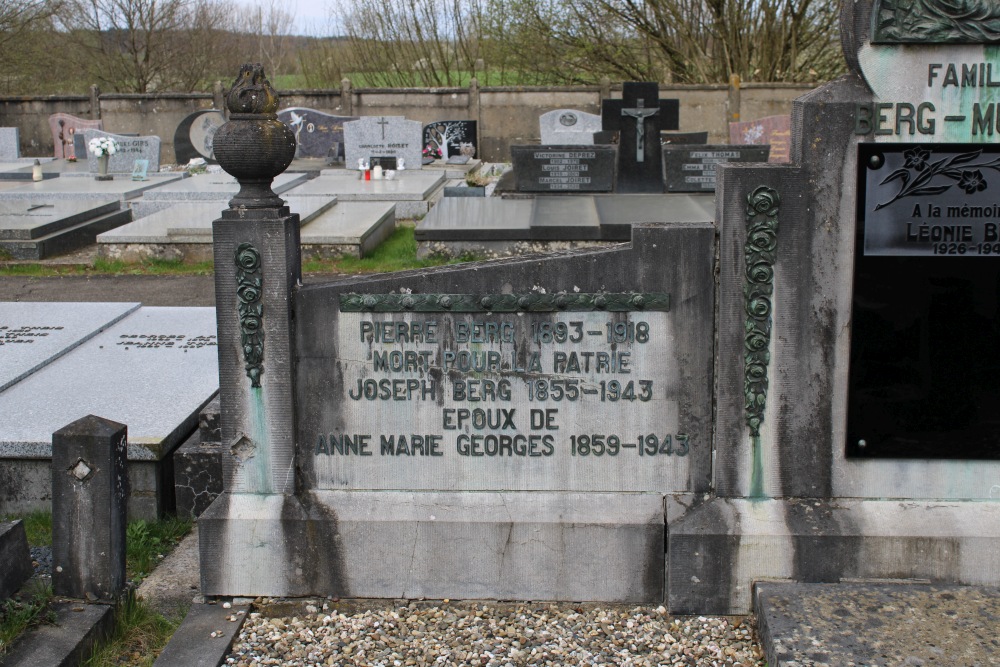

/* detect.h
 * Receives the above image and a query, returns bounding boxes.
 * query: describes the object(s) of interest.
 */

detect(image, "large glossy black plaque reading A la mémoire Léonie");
[846,144,1000,459]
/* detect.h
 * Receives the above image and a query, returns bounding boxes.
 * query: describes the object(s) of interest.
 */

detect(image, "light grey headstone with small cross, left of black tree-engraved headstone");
[344,116,423,170]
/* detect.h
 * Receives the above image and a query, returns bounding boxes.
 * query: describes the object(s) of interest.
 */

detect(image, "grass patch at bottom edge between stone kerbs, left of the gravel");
[83,590,182,667]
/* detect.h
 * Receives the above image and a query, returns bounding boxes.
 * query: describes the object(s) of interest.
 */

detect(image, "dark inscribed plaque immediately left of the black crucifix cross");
[510,146,615,192]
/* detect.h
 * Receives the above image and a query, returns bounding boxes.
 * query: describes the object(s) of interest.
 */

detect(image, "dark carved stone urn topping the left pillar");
[214,63,295,209]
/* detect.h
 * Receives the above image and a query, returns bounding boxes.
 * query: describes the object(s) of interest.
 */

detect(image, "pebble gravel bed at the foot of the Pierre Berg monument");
[225,600,764,667]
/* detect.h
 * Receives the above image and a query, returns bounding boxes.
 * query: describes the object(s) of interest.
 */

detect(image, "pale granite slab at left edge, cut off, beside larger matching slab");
[0,302,139,392]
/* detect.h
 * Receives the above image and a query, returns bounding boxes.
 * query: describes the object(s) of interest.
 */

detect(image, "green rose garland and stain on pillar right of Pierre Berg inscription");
[743,186,781,498]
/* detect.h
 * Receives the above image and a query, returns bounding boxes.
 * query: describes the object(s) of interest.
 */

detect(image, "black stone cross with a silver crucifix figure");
[601,81,680,193]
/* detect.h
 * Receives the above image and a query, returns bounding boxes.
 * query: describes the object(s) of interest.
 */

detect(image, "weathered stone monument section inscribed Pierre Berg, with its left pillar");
[199,64,714,601]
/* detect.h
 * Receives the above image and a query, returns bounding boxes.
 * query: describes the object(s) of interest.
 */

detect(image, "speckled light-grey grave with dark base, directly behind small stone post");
[0,308,218,518]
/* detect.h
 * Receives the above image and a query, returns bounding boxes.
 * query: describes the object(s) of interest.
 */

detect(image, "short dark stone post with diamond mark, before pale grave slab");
[52,415,129,600]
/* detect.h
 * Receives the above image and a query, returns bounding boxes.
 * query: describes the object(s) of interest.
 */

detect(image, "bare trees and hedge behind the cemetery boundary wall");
[0,0,845,94]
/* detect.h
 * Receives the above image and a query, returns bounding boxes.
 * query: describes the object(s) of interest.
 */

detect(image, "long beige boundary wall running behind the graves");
[0,80,814,164]
